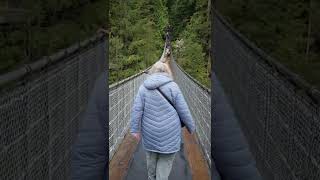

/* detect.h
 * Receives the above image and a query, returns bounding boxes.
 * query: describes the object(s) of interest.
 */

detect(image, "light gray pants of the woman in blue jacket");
[146,151,176,180]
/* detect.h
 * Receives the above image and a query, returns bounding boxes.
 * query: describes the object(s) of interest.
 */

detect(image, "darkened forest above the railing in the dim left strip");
[0,0,108,74]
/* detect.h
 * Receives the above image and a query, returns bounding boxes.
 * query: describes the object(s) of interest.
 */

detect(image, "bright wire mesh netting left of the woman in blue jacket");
[109,73,147,160]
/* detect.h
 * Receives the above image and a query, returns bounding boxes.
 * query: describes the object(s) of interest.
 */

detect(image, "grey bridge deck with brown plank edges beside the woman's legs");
[109,129,210,180]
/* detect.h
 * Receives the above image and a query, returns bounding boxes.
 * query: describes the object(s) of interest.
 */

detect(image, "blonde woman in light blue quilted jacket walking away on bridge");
[130,61,195,180]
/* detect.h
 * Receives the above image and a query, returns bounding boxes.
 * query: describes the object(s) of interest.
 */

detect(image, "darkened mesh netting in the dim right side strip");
[213,11,320,180]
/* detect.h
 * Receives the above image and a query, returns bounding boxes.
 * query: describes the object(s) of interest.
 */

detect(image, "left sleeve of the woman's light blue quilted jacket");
[130,86,144,133]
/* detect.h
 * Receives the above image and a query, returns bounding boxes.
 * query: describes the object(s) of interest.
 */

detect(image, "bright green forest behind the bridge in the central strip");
[109,0,210,87]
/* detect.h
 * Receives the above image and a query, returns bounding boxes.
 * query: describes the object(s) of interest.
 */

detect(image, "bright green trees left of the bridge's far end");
[109,0,168,84]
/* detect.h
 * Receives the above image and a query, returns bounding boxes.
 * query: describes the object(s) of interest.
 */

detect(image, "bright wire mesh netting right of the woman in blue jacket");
[171,58,211,168]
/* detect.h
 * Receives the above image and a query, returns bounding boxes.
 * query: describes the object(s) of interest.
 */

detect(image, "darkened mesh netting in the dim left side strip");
[0,34,106,180]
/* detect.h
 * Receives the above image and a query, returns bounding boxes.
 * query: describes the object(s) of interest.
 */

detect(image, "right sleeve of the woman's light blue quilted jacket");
[175,87,195,133]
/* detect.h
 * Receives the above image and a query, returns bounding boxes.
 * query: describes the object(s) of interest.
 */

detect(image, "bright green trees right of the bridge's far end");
[174,0,211,87]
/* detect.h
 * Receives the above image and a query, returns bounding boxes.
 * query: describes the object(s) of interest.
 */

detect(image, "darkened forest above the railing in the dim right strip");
[216,0,320,89]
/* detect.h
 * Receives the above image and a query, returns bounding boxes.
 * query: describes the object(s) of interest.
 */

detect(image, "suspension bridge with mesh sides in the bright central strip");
[109,29,211,180]
